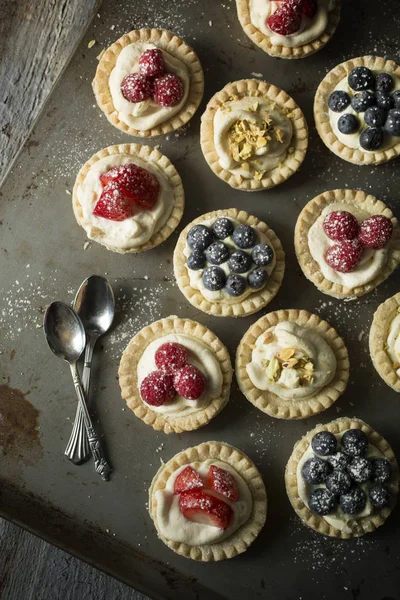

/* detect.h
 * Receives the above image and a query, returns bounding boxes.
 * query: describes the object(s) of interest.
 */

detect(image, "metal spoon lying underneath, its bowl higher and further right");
[65,275,115,464]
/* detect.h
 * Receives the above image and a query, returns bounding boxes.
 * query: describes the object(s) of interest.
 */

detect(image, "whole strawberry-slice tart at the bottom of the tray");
[149,442,267,561]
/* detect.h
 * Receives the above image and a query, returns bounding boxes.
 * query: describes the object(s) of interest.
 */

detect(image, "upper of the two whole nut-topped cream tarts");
[200,79,308,192]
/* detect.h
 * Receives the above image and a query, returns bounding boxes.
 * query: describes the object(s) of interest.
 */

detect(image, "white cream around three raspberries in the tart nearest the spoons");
[137,333,223,418]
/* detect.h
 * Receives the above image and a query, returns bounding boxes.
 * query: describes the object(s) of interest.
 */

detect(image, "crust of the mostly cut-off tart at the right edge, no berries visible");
[369,292,400,392]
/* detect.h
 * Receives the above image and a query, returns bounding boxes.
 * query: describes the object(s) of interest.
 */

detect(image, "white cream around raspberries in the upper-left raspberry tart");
[108,42,190,131]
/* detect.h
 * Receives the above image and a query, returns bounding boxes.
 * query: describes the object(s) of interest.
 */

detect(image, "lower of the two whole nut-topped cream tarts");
[236,309,349,419]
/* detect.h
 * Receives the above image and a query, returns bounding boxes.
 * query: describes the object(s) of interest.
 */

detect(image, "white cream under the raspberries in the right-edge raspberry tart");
[308,202,387,290]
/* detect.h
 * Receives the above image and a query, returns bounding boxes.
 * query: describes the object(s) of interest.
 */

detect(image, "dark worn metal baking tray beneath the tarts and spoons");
[0,0,400,600]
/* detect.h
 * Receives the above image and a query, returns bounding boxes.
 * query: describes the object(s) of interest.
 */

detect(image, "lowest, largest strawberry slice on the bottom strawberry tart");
[179,490,233,529]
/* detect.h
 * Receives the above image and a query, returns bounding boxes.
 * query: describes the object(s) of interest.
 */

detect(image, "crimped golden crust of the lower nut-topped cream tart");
[235,309,350,419]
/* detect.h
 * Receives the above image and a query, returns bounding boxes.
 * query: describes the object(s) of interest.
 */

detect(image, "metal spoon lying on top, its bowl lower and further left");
[43,302,111,481]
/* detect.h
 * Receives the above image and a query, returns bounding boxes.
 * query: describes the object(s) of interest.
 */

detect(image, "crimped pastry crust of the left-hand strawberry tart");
[72,144,185,254]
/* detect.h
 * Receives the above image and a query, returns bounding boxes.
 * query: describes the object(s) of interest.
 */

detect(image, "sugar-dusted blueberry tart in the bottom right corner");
[285,417,399,539]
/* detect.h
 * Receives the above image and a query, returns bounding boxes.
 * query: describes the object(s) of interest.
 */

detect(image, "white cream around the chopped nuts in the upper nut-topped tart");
[214,96,292,179]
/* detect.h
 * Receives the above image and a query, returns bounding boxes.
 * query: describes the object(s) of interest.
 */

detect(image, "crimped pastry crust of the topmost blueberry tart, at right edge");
[314,56,400,165]
